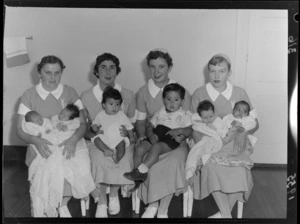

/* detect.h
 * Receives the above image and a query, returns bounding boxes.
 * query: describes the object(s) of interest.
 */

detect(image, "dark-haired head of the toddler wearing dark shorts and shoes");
[162,83,185,112]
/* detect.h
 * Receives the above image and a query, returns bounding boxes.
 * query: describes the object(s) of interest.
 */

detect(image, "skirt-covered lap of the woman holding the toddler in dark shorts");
[138,146,187,204]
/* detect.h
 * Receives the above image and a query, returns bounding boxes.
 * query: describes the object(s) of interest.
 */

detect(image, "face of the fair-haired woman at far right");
[208,61,230,91]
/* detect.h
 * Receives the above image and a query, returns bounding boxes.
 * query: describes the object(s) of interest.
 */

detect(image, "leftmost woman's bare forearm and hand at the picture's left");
[17,114,52,159]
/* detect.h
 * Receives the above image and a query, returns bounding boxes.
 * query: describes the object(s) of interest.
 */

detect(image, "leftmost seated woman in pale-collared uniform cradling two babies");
[17,55,95,217]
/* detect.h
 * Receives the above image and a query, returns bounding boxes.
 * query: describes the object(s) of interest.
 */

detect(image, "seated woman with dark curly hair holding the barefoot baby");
[81,53,136,218]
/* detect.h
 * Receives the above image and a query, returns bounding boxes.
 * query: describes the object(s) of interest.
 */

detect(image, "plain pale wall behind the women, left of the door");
[3,7,286,163]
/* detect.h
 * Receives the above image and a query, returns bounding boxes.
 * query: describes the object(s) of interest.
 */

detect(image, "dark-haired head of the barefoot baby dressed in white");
[101,86,123,115]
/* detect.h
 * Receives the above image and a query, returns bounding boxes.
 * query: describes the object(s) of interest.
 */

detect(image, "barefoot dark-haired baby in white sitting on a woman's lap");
[91,87,135,163]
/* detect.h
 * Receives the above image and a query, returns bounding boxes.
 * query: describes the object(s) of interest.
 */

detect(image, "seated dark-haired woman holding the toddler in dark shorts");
[134,49,191,218]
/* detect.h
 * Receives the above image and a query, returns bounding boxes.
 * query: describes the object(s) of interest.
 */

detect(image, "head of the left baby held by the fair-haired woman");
[197,100,216,124]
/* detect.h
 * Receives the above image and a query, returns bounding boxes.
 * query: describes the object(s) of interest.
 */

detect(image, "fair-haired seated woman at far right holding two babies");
[191,54,258,218]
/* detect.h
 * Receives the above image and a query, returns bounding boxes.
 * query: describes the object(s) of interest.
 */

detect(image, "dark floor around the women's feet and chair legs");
[2,149,287,220]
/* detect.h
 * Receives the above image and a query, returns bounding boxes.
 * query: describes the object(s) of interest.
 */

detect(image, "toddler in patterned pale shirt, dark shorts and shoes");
[124,83,192,185]
